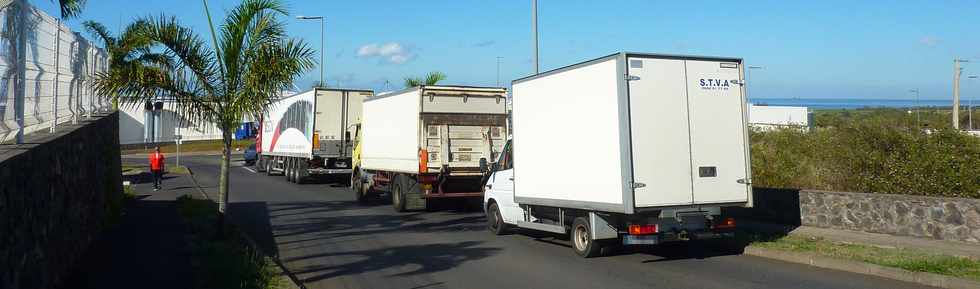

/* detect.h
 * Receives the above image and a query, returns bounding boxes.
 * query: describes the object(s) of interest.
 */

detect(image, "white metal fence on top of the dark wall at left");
[0,0,112,143]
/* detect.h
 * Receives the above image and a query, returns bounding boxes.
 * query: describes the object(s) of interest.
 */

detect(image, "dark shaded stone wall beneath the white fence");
[0,113,122,289]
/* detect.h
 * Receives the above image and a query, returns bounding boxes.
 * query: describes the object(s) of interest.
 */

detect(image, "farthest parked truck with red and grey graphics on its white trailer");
[255,88,374,183]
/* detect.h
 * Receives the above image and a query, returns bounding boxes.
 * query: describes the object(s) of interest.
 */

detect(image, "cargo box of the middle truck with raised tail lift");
[361,86,507,176]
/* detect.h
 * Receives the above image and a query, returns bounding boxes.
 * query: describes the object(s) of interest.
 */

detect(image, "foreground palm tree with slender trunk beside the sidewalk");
[96,0,314,236]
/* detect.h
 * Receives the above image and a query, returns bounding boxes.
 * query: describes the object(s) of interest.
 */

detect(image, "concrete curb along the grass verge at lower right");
[744,246,980,289]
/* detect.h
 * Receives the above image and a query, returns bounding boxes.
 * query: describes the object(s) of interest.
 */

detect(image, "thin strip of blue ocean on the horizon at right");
[749,98,964,109]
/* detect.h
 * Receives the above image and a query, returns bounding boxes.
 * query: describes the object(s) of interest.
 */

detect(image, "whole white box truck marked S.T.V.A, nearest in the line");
[481,53,752,257]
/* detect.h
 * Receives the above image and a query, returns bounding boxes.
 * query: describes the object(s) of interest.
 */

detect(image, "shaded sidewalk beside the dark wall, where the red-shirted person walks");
[64,170,205,288]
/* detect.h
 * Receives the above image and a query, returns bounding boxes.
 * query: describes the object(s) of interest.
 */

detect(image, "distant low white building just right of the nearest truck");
[748,104,813,130]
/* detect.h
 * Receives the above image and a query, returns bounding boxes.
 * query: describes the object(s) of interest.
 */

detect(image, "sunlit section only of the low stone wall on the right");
[799,190,980,243]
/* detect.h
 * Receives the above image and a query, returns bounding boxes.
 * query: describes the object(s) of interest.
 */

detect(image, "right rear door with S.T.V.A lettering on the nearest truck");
[686,60,749,204]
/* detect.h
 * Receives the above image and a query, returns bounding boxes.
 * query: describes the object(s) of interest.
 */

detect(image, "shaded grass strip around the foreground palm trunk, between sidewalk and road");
[177,196,286,289]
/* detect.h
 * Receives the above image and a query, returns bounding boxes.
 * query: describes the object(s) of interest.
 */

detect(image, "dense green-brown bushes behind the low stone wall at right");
[750,109,980,198]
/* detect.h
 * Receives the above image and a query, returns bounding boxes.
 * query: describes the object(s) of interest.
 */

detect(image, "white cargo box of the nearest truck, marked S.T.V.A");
[513,53,752,213]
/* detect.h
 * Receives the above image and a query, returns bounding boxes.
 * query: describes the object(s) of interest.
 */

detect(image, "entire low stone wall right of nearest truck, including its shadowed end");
[736,188,980,243]
